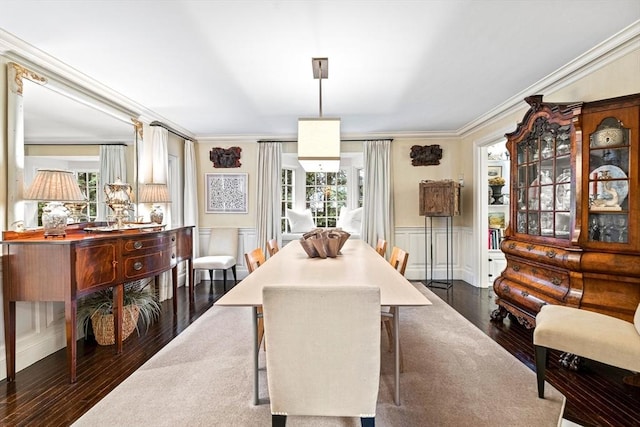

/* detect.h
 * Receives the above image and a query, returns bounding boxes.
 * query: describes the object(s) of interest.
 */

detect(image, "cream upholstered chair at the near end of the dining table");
[262,285,380,426]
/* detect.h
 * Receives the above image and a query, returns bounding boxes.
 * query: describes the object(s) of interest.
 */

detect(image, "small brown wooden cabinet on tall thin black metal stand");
[418,180,460,290]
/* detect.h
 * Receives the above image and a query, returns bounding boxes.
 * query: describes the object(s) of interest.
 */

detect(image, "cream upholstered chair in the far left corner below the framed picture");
[192,228,238,292]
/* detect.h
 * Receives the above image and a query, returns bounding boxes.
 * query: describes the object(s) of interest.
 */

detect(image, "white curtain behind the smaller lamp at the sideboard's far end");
[151,126,174,301]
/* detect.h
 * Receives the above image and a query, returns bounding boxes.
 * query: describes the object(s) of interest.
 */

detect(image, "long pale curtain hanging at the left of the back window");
[256,142,282,253]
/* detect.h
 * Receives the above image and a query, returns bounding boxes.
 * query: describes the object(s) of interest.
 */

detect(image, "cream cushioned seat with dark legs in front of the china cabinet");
[533,305,640,398]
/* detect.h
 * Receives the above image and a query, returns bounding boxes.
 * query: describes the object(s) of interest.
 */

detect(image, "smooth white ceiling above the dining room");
[0,0,640,143]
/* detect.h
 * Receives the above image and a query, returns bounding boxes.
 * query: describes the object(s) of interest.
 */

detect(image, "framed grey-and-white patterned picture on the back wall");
[205,173,249,213]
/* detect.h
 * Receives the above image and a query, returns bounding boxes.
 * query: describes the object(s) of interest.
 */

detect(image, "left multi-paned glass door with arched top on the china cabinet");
[514,117,575,240]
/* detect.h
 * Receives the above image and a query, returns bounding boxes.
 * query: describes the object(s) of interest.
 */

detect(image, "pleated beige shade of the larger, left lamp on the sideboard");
[24,169,86,202]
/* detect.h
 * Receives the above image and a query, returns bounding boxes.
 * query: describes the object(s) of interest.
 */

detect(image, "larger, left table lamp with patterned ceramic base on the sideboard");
[25,169,85,238]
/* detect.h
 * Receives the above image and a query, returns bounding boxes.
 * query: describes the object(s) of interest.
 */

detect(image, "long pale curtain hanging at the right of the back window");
[362,139,395,254]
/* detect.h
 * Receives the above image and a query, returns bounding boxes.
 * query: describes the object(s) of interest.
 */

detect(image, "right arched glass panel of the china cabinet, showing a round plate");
[587,116,630,244]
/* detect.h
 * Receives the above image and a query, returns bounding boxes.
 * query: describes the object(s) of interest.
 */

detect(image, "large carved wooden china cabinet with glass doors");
[492,94,640,327]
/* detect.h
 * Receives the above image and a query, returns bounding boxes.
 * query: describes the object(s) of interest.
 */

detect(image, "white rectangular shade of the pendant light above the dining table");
[298,117,340,172]
